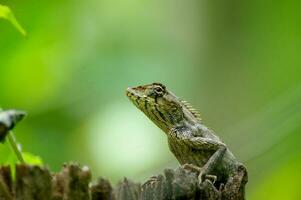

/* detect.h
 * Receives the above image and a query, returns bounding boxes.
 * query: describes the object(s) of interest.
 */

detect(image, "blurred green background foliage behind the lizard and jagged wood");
[0,0,301,200]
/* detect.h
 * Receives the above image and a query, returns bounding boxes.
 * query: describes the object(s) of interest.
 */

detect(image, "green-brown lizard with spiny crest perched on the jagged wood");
[126,83,247,197]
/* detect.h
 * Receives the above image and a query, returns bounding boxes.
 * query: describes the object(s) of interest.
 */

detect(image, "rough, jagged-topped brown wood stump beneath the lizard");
[0,164,244,200]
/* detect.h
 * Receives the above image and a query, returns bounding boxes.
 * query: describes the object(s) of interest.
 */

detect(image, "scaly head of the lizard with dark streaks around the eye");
[126,83,197,131]
